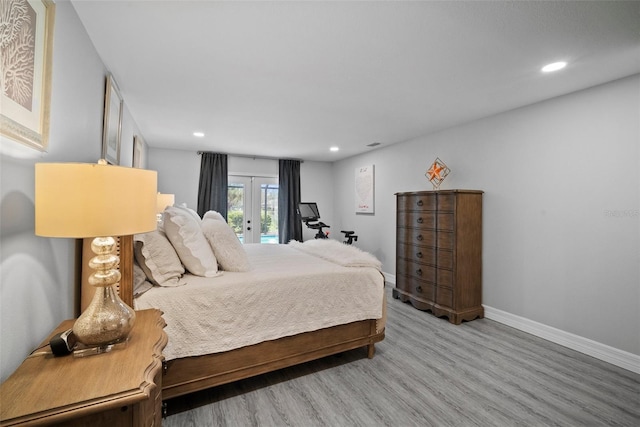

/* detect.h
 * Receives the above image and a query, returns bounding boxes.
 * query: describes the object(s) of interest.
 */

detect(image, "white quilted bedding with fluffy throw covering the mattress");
[134,241,384,360]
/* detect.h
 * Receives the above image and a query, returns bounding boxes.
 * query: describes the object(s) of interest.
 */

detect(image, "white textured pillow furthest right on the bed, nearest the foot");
[200,218,251,271]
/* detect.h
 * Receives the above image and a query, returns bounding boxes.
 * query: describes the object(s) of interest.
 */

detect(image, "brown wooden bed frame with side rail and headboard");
[80,236,386,400]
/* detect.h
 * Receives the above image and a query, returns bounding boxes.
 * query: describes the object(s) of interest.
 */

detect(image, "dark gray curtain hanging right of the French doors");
[278,160,302,243]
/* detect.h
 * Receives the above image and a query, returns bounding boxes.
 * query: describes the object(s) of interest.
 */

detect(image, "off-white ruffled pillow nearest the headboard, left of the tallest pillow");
[133,230,184,292]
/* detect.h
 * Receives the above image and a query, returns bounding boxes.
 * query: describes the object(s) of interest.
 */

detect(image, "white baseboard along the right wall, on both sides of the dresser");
[382,272,640,374]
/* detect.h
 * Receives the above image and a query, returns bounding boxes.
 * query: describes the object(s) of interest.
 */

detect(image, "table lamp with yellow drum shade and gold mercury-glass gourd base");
[35,160,157,347]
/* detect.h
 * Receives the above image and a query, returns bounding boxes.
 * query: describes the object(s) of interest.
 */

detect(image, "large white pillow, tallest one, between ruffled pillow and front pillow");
[164,206,218,277]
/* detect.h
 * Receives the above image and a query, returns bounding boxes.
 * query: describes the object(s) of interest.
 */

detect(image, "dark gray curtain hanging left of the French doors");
[198,152,229,220]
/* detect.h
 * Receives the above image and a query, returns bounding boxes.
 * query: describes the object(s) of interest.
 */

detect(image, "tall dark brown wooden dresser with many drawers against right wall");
[393,190,484,324]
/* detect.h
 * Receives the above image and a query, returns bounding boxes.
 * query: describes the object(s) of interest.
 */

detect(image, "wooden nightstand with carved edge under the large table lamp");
[0,310,167,427]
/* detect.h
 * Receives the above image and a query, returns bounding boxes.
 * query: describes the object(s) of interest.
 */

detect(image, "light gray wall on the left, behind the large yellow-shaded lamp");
[0,1,145,381]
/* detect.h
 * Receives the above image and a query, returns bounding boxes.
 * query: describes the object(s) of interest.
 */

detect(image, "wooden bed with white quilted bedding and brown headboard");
[81,207,386,400]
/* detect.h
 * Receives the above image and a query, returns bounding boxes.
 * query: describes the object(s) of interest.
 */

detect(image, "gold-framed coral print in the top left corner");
[0,0,55,151]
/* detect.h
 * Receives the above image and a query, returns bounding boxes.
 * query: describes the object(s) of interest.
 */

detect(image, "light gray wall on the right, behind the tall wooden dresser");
[333,75,640,355]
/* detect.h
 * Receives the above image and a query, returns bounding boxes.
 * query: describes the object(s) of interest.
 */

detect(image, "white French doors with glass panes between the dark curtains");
[227,175,278,243]
